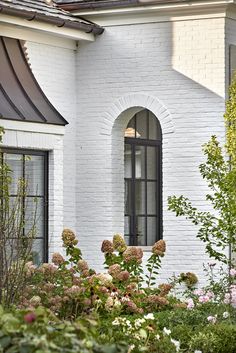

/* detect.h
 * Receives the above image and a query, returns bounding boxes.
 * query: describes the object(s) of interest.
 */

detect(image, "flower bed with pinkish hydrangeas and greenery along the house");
[0,229,236,353]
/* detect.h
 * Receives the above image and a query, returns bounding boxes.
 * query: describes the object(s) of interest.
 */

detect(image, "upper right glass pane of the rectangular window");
[25,155,44,195]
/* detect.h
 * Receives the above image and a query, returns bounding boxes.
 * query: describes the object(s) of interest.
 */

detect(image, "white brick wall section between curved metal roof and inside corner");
[27,42,77,252]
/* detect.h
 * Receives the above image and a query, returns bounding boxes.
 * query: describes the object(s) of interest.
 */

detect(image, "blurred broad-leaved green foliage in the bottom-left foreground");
[0,307,127,353]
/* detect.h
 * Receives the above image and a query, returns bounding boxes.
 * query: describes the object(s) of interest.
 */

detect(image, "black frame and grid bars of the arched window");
[124,109,163,247]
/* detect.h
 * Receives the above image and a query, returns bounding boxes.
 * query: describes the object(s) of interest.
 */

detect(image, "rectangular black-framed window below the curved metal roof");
[0,149,48,264]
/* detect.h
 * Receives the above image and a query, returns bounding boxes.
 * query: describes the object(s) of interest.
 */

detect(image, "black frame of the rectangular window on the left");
[0,147,49,262]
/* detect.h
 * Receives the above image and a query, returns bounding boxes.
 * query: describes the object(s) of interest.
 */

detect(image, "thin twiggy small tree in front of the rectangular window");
[0,128,36,306]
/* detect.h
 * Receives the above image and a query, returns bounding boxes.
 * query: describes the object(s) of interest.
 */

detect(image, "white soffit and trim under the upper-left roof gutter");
[0,14,94,49]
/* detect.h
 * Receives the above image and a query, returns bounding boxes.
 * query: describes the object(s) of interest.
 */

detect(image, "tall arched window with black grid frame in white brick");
[124,109,162,246]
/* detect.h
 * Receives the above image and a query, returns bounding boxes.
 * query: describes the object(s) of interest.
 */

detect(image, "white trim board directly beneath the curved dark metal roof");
[0,119,65,135]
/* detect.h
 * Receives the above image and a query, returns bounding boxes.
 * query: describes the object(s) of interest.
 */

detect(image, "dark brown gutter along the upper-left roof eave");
[0,5,104,35]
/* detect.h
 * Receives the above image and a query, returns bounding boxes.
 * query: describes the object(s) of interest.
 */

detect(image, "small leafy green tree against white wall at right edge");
[168,79,236,263]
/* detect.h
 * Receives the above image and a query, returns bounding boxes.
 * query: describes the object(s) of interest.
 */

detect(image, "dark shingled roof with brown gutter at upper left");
[0,0,103,34]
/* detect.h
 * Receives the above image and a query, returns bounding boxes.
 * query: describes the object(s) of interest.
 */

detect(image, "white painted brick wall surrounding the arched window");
[76,19,225,279]
